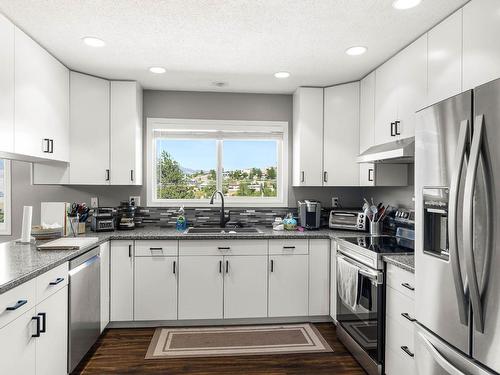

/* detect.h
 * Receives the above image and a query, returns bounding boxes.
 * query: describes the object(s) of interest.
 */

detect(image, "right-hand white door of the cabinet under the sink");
[223,255,267,319]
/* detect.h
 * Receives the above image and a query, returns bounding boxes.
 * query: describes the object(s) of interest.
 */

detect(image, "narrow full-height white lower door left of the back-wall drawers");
[110,241,134,322]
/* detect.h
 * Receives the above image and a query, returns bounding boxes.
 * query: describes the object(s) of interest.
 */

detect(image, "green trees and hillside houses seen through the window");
[157,150,277,199]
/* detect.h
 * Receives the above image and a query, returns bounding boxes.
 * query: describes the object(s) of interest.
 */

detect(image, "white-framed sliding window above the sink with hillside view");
[147,119,288,206]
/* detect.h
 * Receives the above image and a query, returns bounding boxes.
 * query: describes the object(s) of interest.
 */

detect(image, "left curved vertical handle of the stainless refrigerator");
[448,120,470,325]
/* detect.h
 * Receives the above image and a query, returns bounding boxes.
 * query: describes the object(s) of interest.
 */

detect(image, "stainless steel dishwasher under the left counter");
[68,247,101,373]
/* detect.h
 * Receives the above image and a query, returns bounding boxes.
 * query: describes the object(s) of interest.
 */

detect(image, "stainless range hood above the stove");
[357,137,415,164]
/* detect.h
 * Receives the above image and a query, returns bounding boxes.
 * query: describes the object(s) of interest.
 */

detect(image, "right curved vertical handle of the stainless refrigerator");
[463,115,493,333]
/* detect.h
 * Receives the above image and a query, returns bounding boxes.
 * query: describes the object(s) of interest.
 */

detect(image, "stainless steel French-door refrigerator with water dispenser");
[415,80,500,375]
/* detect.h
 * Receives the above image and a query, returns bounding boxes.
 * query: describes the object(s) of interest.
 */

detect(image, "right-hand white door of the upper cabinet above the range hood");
[393,35,427,138]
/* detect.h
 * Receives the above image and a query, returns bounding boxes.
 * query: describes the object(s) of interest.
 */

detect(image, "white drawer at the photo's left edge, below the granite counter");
[0,279,36,328]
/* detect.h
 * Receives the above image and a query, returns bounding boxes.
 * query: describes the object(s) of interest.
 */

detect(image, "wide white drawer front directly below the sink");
[179,240,267,256]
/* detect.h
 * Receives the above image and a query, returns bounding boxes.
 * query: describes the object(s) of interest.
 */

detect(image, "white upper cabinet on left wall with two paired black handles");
[14,28,69,162]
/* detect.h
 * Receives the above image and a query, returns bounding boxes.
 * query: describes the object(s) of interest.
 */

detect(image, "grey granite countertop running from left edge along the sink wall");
[0,227,359,294]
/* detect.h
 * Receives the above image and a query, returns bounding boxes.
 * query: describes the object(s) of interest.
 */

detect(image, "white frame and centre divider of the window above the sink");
[146,118,289,207]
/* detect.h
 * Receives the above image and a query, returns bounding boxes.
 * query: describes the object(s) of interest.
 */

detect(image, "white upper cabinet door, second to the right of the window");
[323,82,359,186]
